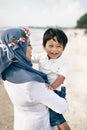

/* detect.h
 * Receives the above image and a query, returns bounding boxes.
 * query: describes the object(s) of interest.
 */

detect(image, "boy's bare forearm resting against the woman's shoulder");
[49,75,65,90]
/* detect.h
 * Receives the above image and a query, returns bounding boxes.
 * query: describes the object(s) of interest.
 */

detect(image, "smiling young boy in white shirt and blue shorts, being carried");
[32,28,70,130]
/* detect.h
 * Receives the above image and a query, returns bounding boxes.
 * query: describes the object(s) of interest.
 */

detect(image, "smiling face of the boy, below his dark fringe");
[44,39,64,59]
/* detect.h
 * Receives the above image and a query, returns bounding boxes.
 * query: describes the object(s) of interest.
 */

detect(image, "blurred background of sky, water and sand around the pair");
[0,0,87,130]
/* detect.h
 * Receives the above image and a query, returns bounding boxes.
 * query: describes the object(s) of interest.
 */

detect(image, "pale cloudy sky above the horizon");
[0,0,87,27]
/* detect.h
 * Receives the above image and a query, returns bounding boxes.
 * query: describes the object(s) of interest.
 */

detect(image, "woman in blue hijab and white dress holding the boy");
[0,28,67,130]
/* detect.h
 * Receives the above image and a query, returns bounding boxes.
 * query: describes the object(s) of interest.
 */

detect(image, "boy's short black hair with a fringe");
[43,28,68,49]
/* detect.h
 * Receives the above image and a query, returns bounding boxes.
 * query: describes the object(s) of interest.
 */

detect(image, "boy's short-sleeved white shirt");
[32,53,68,90]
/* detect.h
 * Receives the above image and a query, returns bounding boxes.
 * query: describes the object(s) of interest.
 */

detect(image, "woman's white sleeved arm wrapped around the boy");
[30,82,68,113]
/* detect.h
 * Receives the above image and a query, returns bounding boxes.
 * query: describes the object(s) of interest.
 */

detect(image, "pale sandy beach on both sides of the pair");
[0,29,87,130]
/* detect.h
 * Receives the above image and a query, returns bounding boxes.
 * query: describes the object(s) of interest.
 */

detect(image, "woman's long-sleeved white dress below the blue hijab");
[4,81,68,130]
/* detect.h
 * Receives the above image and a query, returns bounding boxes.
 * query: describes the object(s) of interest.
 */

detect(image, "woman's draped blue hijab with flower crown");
[1,28,48,83]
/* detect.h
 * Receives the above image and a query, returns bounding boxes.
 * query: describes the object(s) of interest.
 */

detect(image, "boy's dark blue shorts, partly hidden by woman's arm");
[49,87,66,126]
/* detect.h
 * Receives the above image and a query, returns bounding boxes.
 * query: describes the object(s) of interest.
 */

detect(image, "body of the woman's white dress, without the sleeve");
[4,81,50,130]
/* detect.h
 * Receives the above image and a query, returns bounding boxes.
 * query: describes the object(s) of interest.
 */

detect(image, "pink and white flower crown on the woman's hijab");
[9,27,31,46]
